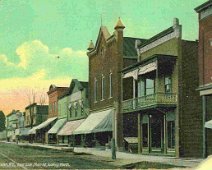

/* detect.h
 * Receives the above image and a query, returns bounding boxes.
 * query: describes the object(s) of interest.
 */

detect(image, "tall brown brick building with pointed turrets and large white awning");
[80,19,146,149]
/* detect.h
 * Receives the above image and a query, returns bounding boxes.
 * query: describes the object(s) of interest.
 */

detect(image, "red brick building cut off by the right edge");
[195,0,212,157]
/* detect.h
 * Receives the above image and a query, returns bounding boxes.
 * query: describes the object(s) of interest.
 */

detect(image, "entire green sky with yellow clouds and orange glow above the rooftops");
[0,0,206,114]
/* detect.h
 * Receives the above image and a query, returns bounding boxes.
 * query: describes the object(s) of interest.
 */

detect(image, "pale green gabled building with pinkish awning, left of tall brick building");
[57,79,89,146]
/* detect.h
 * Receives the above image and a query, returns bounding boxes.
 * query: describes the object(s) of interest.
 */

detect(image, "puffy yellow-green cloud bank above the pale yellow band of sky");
[0,40,88,80]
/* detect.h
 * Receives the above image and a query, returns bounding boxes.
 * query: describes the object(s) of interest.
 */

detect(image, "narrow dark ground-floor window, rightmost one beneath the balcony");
[167,121,175,148]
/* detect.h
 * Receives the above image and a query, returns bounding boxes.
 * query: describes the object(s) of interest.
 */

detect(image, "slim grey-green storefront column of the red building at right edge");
[202,96,206,158]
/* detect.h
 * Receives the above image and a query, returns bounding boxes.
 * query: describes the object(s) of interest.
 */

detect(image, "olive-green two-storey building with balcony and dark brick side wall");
[122,18,202,157]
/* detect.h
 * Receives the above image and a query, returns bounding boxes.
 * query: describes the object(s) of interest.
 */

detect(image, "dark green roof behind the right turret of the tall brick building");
[123,37,146,59]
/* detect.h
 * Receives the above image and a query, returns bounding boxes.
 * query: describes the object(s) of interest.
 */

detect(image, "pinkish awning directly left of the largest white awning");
[57,119,85,136]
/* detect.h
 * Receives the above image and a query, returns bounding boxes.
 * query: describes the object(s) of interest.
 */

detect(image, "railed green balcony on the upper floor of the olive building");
[122,93,177,113]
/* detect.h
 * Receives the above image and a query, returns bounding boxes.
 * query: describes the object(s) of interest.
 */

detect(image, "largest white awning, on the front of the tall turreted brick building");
[73,109,114,134]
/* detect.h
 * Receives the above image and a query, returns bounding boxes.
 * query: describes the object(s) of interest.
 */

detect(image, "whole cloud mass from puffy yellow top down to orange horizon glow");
[0,40,88,113]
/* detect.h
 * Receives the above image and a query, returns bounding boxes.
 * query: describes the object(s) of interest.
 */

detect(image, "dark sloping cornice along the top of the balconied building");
[139,26,174,48]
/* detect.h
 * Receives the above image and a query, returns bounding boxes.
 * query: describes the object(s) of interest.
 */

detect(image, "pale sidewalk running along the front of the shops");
[2,142,203,169]
